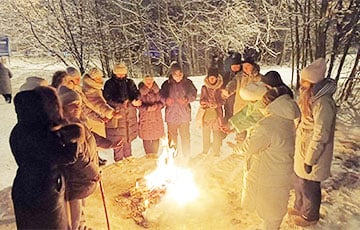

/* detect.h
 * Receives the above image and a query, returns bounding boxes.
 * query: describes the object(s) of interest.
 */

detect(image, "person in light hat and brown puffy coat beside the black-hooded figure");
[58,86,100,230]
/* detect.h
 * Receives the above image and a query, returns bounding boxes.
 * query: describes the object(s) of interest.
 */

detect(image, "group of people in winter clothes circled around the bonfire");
[10,52,336,229]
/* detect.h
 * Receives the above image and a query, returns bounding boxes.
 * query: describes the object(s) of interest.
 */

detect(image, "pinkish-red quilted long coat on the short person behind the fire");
[139,82,164,140]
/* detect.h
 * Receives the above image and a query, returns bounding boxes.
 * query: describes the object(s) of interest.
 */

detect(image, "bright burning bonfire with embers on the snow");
[115,140,199,228]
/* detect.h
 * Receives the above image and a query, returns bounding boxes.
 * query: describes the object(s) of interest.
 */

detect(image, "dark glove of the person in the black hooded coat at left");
[58,124,85,143]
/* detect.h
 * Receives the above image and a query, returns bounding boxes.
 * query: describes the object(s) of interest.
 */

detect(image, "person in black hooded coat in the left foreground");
[10,86,84,229]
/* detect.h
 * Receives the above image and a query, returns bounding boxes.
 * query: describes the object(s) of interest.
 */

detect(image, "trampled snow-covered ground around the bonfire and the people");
[0,58,360,230]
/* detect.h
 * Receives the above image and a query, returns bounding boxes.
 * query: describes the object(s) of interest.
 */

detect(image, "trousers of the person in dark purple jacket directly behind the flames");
[167,122,191,156]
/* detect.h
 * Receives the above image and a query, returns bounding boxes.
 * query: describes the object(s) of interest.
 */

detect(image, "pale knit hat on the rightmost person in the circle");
[300,58,326,83]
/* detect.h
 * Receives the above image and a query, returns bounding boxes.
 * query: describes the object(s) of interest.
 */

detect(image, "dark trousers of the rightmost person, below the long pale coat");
[294,175,321,221]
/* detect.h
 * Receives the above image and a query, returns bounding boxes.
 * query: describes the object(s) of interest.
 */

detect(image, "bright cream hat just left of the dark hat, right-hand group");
[239,81,267,101]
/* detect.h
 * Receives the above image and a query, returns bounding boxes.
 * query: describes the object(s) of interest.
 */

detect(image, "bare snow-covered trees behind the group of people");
[0,0,360,104]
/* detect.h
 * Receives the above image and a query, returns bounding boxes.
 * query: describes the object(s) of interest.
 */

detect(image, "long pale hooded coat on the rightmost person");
[294,78,336,181]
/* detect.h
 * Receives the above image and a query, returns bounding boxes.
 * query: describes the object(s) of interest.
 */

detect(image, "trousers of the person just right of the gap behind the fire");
[203,126,222,155]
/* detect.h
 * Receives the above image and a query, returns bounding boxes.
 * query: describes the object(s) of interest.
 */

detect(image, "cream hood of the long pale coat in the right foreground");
[266,94,300,120]
